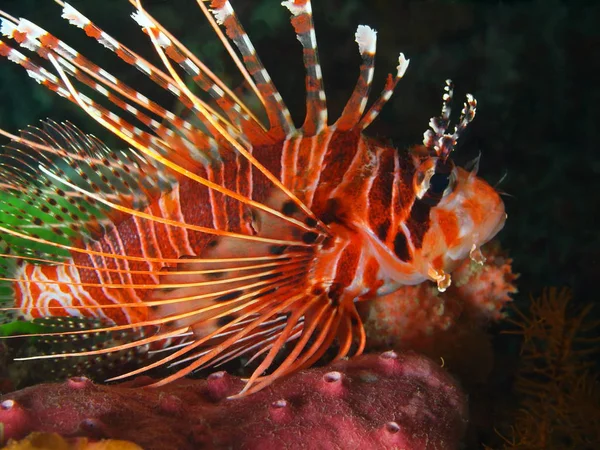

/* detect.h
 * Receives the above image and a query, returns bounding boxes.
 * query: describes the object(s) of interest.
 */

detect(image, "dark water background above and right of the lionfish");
[0,0,600,444]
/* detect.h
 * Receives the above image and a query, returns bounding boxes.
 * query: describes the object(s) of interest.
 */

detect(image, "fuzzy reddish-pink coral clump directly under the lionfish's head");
[359,242,518,380]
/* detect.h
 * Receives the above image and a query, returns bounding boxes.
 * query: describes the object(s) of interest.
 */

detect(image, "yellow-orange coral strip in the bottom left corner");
[3,433,142,450]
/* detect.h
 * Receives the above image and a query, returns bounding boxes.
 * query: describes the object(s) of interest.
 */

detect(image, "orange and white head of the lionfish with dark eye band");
[412,151,506,290]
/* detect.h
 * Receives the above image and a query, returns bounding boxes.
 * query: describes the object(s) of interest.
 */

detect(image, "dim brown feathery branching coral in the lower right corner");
[492,288,600,450]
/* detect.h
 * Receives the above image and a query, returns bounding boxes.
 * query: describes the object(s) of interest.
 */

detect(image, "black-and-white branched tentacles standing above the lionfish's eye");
[423,80,477,160]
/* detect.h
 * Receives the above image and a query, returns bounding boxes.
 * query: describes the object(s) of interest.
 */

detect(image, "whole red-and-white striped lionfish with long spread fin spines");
[0,0,506,395]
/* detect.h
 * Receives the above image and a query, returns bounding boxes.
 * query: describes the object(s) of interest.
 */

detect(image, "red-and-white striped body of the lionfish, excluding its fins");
[16,129,502,324]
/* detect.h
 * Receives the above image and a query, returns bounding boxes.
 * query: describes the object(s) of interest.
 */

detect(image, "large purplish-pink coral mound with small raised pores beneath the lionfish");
[0,351,467,450]
